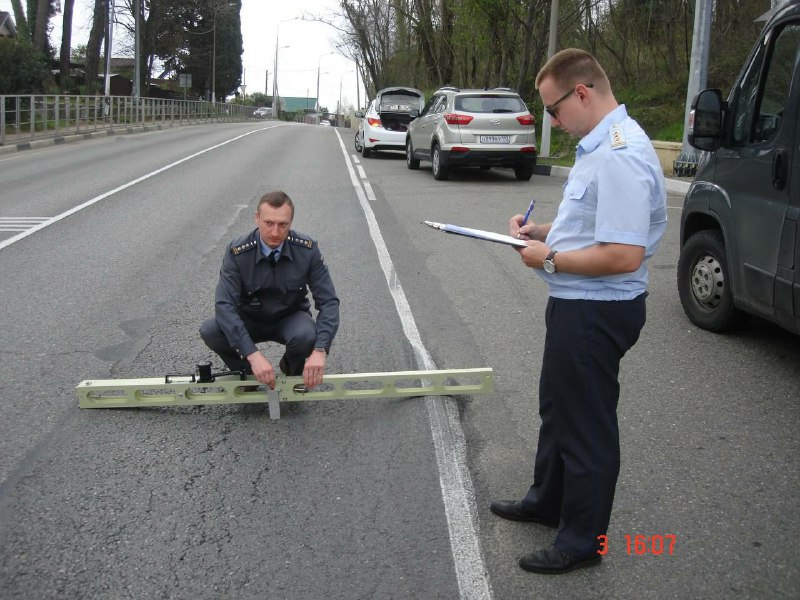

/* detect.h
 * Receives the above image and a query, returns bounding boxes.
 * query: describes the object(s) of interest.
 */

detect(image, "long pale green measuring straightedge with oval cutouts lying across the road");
[75,365,493,420]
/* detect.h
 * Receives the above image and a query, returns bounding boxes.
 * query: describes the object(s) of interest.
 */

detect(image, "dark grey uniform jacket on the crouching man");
[215,229,339,359]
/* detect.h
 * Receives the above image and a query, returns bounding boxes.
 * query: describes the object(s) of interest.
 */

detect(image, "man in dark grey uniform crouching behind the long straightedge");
[200,191,339,389]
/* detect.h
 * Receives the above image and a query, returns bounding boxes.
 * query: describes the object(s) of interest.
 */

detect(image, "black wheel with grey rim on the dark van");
[678,230,747,331]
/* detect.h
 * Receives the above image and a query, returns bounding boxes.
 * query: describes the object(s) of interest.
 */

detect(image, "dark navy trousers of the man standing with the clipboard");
[522,293,647,557]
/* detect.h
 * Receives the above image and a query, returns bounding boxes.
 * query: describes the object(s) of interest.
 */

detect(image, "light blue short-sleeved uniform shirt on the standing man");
[537,105,667,300]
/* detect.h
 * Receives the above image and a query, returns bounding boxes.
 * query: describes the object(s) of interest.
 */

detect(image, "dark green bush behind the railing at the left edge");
[0,38,51,94]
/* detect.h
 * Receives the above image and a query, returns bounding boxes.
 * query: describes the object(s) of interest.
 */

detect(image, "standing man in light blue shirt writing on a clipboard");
[491,48,667,573]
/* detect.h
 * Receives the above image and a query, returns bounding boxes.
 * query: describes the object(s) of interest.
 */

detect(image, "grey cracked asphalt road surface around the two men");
[0,123,800,600]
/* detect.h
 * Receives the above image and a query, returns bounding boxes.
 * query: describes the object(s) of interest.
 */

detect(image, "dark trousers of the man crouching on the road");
[200,310,317,375]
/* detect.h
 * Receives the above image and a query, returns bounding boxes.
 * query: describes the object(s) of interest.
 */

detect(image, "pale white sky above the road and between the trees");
[0,0,366,111]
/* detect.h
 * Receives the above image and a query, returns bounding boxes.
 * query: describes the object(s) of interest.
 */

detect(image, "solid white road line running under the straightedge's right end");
[336,130,492,600]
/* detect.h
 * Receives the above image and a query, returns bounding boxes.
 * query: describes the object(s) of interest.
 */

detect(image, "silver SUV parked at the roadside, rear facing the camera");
[406,87,536,181]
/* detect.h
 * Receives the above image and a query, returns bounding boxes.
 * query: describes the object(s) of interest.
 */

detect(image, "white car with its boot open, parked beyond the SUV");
[355,87,425,158]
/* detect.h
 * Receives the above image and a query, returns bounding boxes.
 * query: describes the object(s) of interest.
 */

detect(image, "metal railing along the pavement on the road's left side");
[0,95,255,146]
